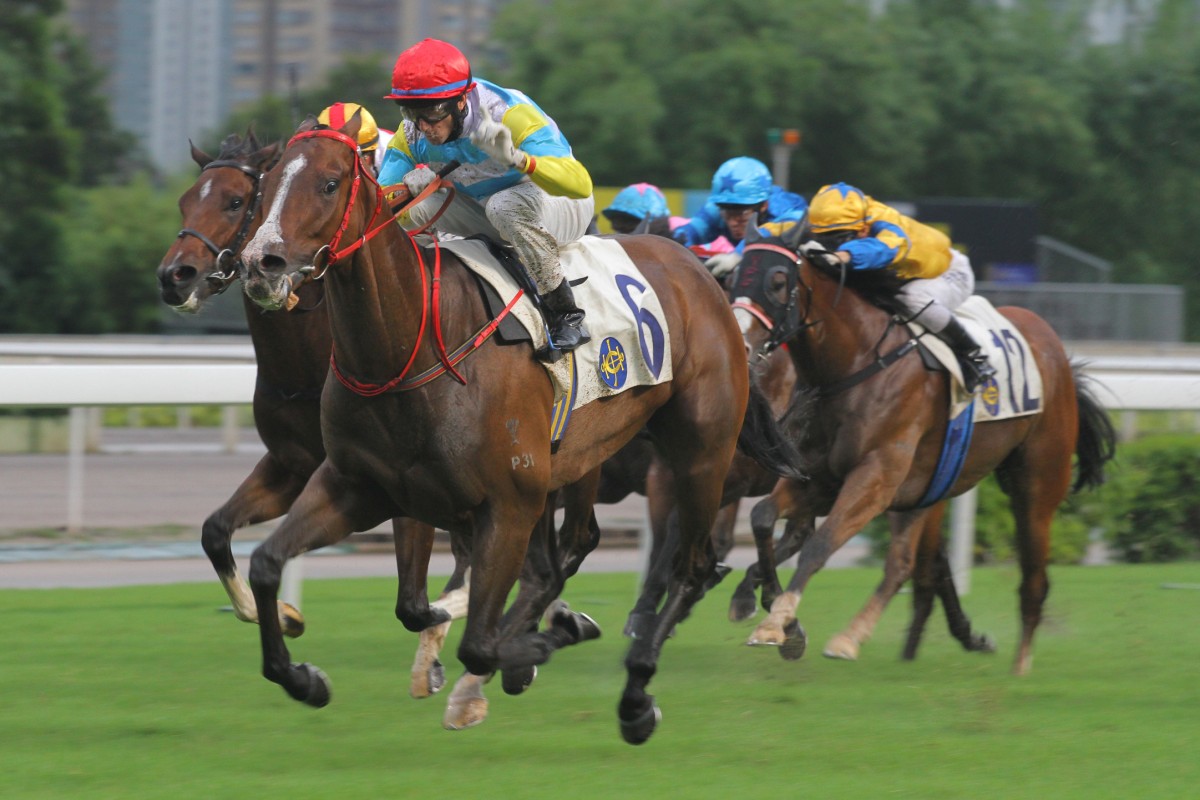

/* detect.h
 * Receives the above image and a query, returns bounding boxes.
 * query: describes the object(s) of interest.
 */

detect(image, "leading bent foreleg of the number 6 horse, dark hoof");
[250,462,396,708]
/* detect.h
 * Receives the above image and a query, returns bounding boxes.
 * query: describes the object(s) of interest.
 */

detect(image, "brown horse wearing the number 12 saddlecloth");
[733,221,1115,674]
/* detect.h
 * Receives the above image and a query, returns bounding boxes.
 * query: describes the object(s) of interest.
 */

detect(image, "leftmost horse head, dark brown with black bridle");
[157,130,280,313]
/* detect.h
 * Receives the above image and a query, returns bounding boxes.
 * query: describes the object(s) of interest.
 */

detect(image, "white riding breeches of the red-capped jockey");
[407,181,595,295]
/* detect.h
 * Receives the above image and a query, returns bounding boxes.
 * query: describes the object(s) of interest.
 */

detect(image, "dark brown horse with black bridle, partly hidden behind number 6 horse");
[157,131,467,693]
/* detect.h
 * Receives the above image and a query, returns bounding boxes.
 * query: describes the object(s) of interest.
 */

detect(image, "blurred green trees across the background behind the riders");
[0,0,1200,341]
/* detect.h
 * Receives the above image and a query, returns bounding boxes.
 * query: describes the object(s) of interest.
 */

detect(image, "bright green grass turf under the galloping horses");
[0,564,1200,800]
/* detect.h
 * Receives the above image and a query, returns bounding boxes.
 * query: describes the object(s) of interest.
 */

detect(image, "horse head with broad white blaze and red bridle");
[242,113,384,309]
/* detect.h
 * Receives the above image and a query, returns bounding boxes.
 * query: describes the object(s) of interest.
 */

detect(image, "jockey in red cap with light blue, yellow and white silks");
[379,38,595,350]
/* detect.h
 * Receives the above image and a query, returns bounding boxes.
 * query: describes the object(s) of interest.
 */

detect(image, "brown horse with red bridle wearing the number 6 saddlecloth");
[232,118,794,744]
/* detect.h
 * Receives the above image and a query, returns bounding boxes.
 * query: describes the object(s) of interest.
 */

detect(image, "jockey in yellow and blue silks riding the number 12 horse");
[800,184,996,392]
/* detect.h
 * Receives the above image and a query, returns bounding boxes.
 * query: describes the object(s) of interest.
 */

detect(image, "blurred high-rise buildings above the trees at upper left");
[66,0,498,172]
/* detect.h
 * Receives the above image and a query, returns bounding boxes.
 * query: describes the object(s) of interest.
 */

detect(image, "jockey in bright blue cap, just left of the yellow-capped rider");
[672,156,808,277]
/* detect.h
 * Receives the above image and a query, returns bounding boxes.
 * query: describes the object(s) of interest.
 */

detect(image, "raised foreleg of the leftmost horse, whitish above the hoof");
[200,453,308,637]
